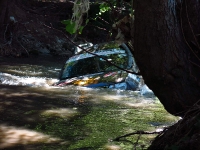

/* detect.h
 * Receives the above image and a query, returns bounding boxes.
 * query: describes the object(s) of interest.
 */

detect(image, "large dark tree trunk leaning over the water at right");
[132,0,200,115]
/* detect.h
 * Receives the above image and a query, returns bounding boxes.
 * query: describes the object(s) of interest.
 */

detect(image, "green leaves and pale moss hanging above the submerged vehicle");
[62,0,133,34]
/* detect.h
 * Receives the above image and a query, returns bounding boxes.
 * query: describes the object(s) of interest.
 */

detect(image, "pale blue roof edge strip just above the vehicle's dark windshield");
[66,48,125,63]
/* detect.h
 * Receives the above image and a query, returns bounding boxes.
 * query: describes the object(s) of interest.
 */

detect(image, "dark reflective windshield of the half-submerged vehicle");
[61,53,128,79]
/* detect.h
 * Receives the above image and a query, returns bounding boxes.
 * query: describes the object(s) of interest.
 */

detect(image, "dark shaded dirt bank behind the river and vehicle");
[0,1,110,58]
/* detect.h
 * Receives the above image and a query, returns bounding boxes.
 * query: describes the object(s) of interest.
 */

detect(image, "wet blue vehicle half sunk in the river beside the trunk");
[56,43,141,90]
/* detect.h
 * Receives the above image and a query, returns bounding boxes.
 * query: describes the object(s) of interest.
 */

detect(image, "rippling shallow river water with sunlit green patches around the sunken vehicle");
[0,57,179,150]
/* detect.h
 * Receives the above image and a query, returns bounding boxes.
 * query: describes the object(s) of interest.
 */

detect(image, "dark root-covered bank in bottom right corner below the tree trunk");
[148,106,200,150]
